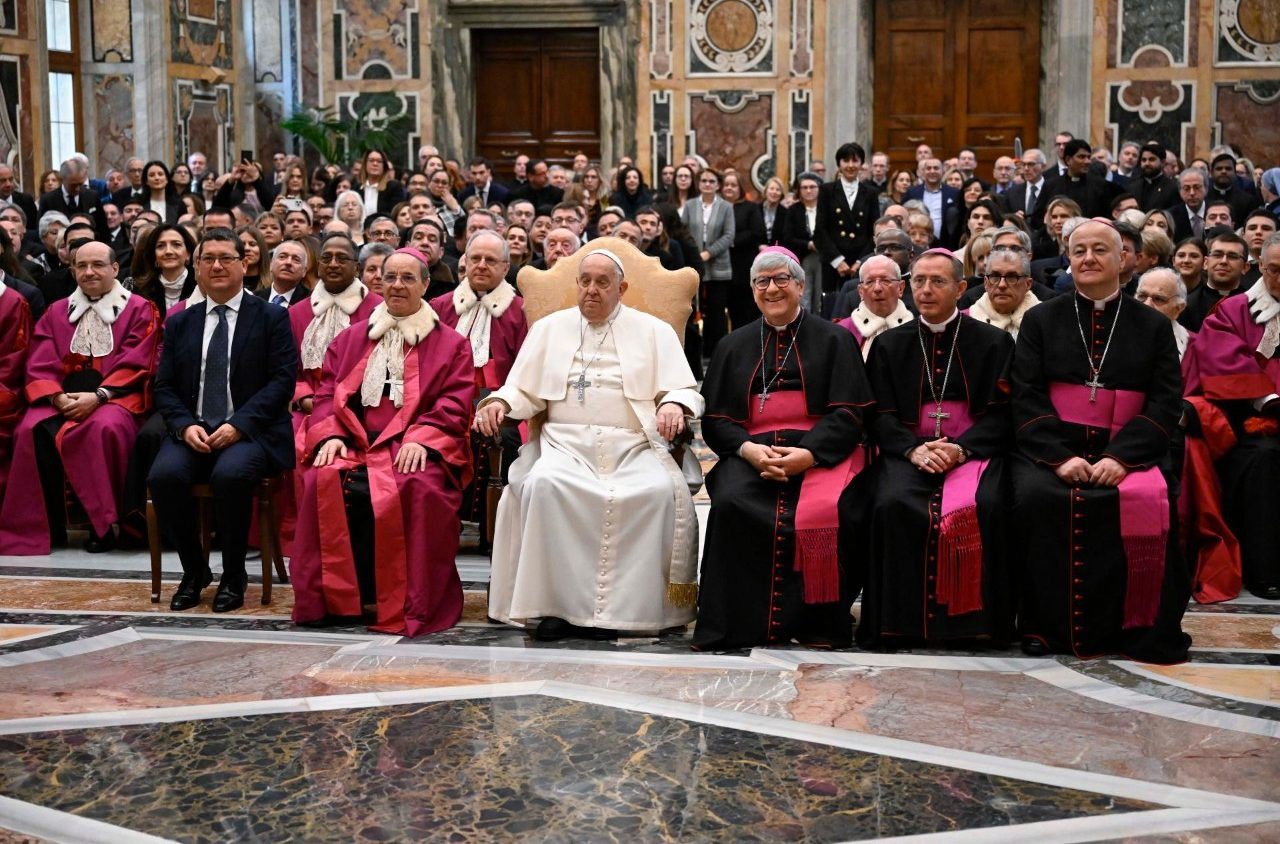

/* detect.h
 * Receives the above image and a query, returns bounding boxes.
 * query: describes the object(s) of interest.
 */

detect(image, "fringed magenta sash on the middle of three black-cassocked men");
[915,400,991,616]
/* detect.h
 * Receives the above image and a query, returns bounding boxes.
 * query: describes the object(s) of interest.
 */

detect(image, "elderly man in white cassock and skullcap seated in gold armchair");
[475,248,703,639]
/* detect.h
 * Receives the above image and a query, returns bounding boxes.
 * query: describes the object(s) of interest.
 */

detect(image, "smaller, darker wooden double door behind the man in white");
[471,29,600,177]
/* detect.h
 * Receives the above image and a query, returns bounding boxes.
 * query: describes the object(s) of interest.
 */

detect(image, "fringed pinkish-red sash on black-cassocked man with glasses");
[746,389,867,603]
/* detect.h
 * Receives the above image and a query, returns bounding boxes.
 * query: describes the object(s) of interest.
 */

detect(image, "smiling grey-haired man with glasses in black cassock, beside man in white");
[694,246,872,651]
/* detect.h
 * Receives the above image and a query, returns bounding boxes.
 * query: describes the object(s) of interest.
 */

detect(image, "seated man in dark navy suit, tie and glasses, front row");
[147,228,298,612]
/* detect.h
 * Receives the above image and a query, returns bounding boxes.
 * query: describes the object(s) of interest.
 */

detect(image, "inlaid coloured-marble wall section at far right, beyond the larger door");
[1093,0,1280,166]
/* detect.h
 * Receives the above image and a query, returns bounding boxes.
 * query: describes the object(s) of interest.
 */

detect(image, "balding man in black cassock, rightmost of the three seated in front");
[1010,222,1190,663]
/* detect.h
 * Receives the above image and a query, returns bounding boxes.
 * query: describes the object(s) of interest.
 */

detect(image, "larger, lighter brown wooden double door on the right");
[874,0,1039,178]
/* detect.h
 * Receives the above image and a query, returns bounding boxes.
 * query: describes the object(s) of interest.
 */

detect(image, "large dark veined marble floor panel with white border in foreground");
[0,695,1155,841]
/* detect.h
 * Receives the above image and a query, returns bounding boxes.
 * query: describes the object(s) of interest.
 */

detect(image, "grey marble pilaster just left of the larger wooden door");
[824,0,876,162]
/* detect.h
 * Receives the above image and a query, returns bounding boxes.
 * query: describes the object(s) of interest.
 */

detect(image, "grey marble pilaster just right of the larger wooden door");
[1039,0,1093,153]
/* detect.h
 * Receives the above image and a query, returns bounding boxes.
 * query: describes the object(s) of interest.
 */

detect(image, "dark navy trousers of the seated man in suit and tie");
[147,439,271,579]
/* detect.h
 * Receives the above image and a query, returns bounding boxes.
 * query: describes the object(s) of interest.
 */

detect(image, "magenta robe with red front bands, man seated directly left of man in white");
[289,313,475,637]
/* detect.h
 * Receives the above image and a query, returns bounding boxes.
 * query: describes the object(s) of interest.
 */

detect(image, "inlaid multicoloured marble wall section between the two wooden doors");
[637,0,827,193]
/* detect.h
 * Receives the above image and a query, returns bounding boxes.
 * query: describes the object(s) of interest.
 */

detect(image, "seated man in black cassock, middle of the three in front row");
[840,250,1014,647]
